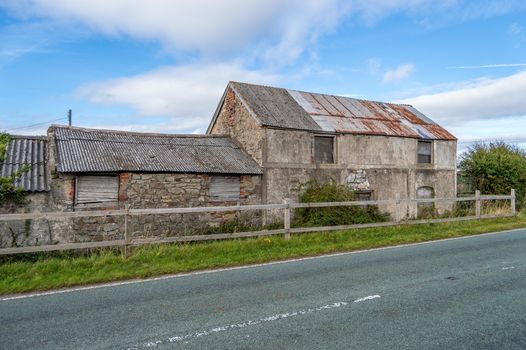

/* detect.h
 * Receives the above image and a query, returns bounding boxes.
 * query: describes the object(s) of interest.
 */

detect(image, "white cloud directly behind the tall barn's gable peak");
[77,62,278,126]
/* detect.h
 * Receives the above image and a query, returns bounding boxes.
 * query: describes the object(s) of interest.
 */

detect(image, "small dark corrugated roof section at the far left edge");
[0,136,50,192]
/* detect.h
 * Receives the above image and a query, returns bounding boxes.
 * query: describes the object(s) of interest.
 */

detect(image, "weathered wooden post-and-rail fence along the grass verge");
[0,190,516,255]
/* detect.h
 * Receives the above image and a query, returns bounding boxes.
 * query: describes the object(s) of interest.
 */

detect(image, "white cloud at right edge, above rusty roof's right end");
[399,71,526,123]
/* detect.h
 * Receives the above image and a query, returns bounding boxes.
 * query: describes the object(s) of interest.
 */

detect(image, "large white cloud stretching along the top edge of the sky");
[0,0,349,62]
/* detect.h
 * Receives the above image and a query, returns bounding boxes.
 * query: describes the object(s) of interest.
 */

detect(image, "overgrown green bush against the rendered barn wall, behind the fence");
[293,181,389,226]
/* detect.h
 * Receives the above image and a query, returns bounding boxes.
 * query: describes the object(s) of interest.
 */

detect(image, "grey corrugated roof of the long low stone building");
[52,126,262,175]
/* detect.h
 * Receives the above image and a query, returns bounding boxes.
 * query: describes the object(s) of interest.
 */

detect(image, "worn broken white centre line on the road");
[127,294,380,350]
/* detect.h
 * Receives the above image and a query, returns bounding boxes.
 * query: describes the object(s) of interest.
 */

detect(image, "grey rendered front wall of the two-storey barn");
[263,129,456,217]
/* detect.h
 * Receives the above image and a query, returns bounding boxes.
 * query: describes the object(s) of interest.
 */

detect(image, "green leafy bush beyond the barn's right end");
[459,141,526,208]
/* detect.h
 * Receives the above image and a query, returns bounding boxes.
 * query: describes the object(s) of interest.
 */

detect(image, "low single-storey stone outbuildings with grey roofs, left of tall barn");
[1,126,262,247]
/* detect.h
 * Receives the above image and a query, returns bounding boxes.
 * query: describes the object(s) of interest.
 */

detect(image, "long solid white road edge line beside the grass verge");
[4,228,525,301]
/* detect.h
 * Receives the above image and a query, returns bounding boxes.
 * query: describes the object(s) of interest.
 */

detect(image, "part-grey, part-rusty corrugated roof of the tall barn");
[229,82,456,140]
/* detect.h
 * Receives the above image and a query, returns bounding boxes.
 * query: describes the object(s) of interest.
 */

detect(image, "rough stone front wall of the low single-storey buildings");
[0,173,261,248]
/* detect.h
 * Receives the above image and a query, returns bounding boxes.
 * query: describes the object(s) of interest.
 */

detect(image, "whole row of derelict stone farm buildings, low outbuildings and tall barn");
[0,82,456,247]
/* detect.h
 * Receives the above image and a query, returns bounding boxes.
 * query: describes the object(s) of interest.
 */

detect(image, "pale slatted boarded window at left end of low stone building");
[76,175,119,204]
